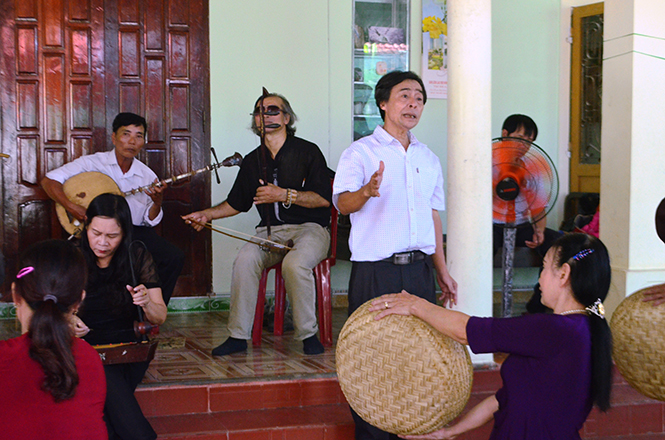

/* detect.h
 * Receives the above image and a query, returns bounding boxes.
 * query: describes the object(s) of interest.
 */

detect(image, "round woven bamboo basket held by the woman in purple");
[336,302,473,435]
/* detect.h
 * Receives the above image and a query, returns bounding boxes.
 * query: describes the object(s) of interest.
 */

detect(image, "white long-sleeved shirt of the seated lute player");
[46,149,164,226]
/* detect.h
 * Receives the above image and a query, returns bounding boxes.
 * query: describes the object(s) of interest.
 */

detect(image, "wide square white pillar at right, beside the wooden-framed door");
[600,0,665,311]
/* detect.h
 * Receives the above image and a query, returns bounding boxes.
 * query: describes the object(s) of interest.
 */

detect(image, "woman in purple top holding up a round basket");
[370,234,612,440]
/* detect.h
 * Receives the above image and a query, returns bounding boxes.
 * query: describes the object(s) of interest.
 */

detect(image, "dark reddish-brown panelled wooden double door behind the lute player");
[0,0,211,299]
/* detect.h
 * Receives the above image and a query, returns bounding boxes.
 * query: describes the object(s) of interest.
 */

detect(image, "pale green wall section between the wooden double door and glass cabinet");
[210,0,352,293]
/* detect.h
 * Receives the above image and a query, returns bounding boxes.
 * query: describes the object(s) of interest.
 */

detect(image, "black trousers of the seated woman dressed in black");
[104,362,157,440]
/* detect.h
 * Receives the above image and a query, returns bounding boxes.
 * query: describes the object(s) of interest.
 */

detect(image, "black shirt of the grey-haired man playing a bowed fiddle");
[226,136,332,227]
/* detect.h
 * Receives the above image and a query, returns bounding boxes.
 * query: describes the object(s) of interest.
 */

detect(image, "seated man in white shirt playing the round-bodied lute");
[41,113,185,304]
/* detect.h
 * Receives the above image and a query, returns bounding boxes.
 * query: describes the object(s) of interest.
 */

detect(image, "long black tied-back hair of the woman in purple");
[552,233,612,411]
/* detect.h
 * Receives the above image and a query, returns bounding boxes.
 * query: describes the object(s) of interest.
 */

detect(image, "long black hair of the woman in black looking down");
[81,193,133,306]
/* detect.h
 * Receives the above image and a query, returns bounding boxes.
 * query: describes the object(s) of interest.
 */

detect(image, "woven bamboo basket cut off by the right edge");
[610,290,665,401]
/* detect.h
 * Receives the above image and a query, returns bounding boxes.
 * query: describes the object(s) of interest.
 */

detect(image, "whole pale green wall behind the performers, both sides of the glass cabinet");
[210,0,570,294]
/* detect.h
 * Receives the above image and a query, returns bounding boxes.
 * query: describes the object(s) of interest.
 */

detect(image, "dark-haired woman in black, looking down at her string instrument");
[74,194,166,440]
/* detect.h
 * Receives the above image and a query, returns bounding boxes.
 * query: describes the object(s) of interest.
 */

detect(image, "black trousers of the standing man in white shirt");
[349,257,436,440]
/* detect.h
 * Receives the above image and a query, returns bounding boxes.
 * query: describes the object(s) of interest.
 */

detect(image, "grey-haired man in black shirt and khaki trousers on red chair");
[183,93,332,356]
